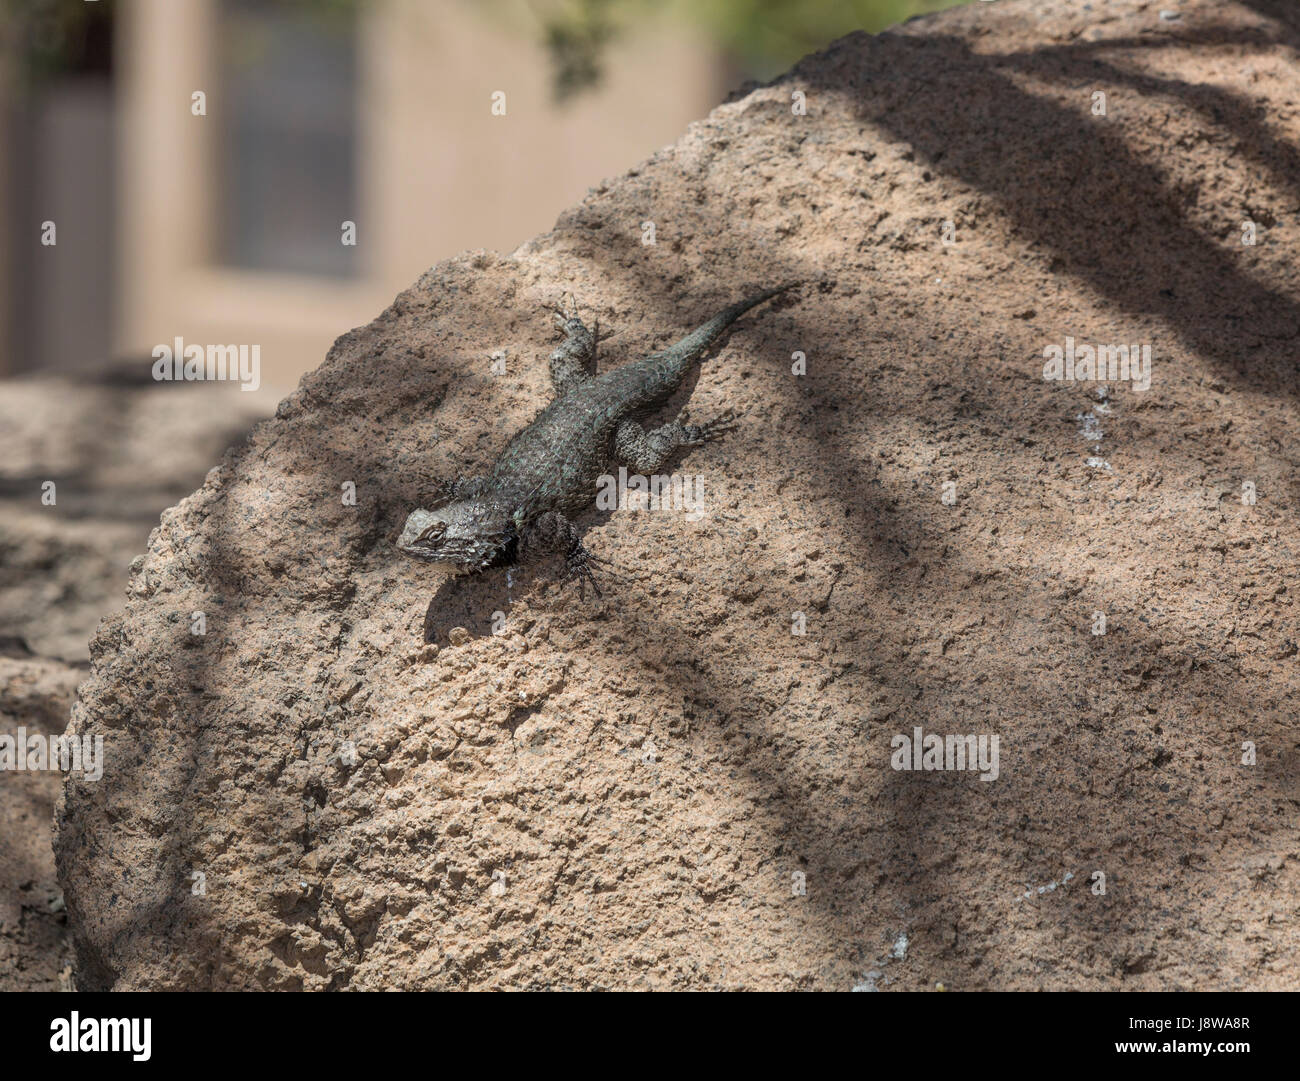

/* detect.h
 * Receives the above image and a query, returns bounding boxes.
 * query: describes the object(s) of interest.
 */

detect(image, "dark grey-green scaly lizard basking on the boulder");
[397,282,800,596]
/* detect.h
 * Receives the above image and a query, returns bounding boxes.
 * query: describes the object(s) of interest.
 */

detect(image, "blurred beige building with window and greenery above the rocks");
[0,0,954,394]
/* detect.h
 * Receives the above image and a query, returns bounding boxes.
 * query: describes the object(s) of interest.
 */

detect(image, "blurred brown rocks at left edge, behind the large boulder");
[0,374,273,990]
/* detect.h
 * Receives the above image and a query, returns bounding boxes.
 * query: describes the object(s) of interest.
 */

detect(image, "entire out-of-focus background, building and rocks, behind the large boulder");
[0,0,972,990]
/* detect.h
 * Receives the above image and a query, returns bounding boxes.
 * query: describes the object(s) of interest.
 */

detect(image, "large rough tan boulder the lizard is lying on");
[56,0,1300,989]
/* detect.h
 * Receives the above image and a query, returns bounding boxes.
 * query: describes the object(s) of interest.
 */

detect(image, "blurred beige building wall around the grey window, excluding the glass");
[117,0,722,391]
